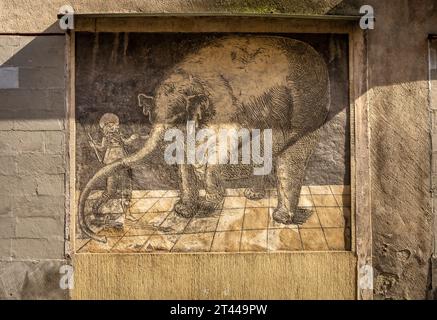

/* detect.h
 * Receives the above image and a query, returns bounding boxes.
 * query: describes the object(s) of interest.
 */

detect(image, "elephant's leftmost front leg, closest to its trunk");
[174,164,199,218]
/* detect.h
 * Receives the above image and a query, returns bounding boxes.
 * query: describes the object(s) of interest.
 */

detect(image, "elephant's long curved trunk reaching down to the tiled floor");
[78,125,165,242]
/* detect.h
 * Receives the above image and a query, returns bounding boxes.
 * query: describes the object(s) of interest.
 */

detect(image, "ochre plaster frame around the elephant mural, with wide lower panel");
[66,15,373,299]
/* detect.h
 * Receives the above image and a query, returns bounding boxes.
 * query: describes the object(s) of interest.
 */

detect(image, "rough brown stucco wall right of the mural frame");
[368,0,437,299]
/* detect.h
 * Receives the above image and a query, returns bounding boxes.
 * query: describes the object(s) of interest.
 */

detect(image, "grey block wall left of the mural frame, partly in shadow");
[0,35,66,298]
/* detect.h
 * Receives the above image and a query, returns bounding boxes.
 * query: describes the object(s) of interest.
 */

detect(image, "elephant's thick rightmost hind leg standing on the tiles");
[273,131,319,224]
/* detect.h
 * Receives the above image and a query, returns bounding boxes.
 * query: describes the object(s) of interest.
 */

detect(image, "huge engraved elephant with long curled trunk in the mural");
[78,35,330,242]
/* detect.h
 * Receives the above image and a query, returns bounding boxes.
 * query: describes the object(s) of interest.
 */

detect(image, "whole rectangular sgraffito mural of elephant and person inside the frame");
[75,33,351,253]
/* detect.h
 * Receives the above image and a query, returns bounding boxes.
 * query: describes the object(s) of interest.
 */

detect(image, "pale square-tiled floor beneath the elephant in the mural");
[75,185,351,253]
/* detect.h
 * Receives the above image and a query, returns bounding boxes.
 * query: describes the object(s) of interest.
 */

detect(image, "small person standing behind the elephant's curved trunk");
[89,113,139,228]
